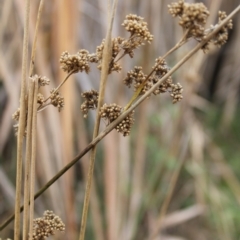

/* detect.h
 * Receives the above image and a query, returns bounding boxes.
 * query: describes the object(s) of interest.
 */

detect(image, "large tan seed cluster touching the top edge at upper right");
[168,0,209,40]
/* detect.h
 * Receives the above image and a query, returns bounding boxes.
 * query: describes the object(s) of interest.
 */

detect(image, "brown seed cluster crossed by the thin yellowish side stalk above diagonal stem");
[123,66,153,95]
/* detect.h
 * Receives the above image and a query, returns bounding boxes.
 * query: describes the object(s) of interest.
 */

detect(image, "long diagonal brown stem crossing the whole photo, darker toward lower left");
[0,5,240,231]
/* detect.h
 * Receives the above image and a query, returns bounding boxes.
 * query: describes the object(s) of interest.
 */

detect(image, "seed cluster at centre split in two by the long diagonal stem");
[100,103,134,137]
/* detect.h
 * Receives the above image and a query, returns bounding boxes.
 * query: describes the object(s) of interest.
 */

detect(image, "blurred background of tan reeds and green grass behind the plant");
[0,0,240,240]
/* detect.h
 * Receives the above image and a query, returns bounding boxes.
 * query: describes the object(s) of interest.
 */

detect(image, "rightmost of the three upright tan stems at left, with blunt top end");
[29,80,38,240]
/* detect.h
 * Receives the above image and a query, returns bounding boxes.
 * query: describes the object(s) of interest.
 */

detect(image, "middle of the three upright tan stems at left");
[23,80,34,240]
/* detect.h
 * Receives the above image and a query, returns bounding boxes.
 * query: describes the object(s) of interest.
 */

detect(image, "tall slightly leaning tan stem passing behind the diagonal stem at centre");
[79,0,118,240]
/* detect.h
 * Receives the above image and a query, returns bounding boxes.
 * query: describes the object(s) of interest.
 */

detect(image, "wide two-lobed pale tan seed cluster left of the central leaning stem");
[60,49,92,73]
